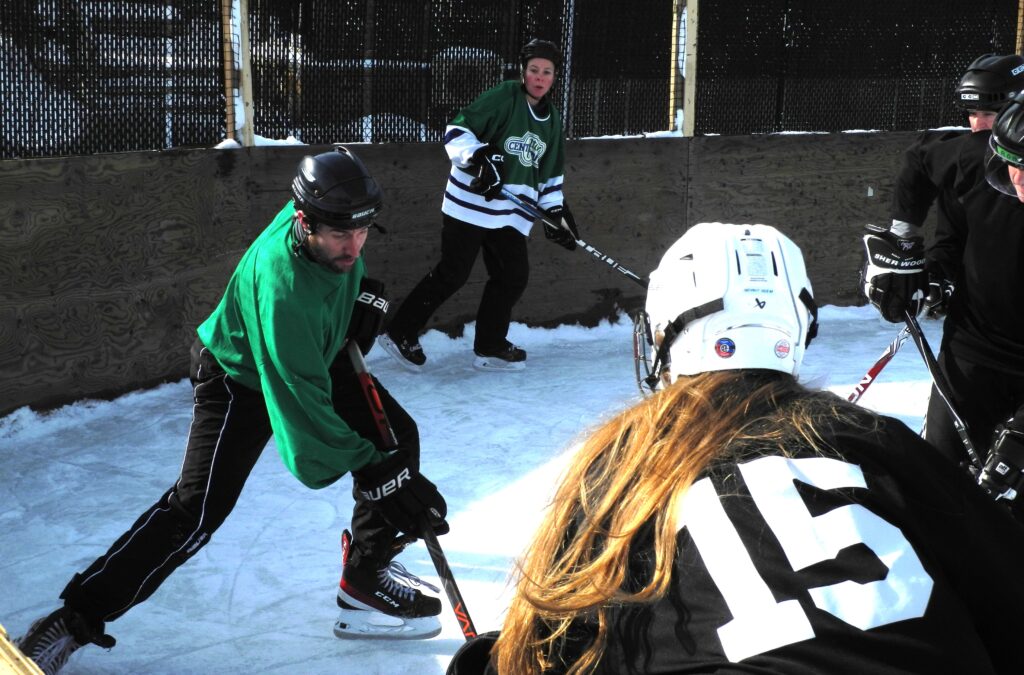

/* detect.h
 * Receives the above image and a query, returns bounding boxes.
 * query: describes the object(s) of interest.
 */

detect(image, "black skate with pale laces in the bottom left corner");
[14,607,115,675]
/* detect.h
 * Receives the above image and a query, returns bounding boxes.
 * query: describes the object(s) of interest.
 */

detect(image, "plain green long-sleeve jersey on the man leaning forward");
[198,203,382,488]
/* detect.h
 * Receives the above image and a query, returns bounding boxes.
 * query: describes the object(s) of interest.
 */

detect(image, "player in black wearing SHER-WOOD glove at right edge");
[864,54,1024,473]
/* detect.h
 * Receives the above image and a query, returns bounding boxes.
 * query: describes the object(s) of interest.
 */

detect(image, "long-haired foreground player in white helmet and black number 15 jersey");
[449,223,1024,675]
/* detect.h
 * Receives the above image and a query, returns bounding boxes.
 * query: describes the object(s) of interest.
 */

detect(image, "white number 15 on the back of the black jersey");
[678,456,933,663]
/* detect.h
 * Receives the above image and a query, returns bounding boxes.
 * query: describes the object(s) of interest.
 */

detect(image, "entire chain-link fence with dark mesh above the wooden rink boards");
[0,0,1021,159]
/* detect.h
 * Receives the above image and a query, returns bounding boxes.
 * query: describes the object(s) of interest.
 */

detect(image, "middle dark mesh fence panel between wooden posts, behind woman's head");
[249,0,672,143]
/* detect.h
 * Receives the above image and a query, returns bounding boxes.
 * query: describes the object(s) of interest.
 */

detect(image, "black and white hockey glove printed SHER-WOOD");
[860,225,928,323]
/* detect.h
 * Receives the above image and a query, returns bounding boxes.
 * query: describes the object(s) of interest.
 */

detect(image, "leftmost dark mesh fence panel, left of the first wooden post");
[0,0,225,159]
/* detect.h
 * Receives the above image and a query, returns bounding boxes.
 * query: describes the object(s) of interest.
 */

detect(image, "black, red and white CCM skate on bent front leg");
[334,530,441,640]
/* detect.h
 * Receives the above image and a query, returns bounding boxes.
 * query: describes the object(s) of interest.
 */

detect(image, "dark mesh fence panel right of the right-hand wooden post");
[694,0,1019,135]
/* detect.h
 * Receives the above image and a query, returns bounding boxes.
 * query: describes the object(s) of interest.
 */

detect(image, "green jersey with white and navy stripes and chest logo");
[441,80,565,235]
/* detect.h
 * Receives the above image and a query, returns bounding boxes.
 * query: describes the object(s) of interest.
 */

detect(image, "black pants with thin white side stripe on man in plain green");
[60,340,411,621]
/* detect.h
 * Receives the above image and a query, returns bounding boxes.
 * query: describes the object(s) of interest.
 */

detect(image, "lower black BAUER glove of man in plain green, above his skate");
[352,451,449,537]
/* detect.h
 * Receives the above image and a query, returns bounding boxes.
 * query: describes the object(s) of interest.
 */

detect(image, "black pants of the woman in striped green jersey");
[388,214,529,352]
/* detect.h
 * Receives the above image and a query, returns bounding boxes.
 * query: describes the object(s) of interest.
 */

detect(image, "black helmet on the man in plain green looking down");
[292,145,384,229]
